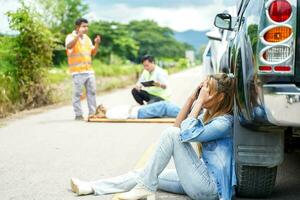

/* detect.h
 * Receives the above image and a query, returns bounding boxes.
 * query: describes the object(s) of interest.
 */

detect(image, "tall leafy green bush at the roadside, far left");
[8,1,53,108]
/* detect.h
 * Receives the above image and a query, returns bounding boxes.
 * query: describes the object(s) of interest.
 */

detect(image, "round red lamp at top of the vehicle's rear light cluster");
[269,0,292,23]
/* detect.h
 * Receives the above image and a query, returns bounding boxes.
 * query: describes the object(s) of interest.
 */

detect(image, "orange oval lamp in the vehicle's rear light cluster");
[264,26,293,43]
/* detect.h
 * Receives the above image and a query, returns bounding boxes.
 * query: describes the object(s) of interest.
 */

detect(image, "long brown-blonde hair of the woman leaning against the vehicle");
[197,73,235,155]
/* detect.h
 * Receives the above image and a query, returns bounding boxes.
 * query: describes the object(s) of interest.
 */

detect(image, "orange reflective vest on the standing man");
[67,35,92,74]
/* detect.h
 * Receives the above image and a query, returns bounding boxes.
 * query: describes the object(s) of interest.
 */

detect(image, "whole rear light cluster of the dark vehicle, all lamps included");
[258,0,297,76]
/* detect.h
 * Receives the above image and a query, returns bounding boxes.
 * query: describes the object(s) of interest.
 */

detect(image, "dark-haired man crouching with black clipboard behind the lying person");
[131,55,170,105]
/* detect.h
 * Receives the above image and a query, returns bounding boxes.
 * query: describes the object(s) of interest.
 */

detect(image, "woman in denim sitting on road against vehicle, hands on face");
[71,74,236,200]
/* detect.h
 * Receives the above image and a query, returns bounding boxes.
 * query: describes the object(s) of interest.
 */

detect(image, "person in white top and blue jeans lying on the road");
[94,101,180,119]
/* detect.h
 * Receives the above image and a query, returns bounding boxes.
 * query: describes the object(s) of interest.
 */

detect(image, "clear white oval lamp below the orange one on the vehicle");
[262,46,291,64]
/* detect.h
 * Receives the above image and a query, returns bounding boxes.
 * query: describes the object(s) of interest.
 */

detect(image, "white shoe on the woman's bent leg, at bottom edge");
[119,184,155,200]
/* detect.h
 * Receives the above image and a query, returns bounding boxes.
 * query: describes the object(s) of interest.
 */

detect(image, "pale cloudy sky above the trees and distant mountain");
[0,0,236,33]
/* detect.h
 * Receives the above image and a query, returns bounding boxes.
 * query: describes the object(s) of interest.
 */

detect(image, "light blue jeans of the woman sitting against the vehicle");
[91,127,218,200]
